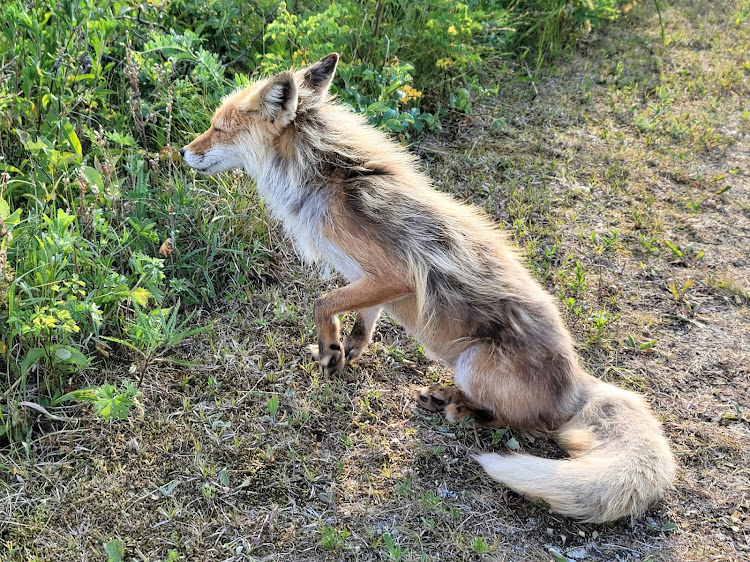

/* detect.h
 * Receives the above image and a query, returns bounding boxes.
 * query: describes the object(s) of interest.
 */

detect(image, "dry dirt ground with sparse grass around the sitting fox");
[0,0,750,562]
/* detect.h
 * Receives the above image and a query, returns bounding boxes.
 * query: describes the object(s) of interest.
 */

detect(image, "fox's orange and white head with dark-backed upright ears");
[180,53,339,179]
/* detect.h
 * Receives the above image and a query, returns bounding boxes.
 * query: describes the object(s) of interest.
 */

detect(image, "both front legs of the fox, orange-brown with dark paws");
[309,278,411,374]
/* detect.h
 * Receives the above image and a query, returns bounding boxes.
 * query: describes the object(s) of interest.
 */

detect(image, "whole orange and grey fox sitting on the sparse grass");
[180,53,676,523]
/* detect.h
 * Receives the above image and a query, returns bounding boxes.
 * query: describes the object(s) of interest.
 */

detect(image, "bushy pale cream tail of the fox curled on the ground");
[476,377,675,523]
